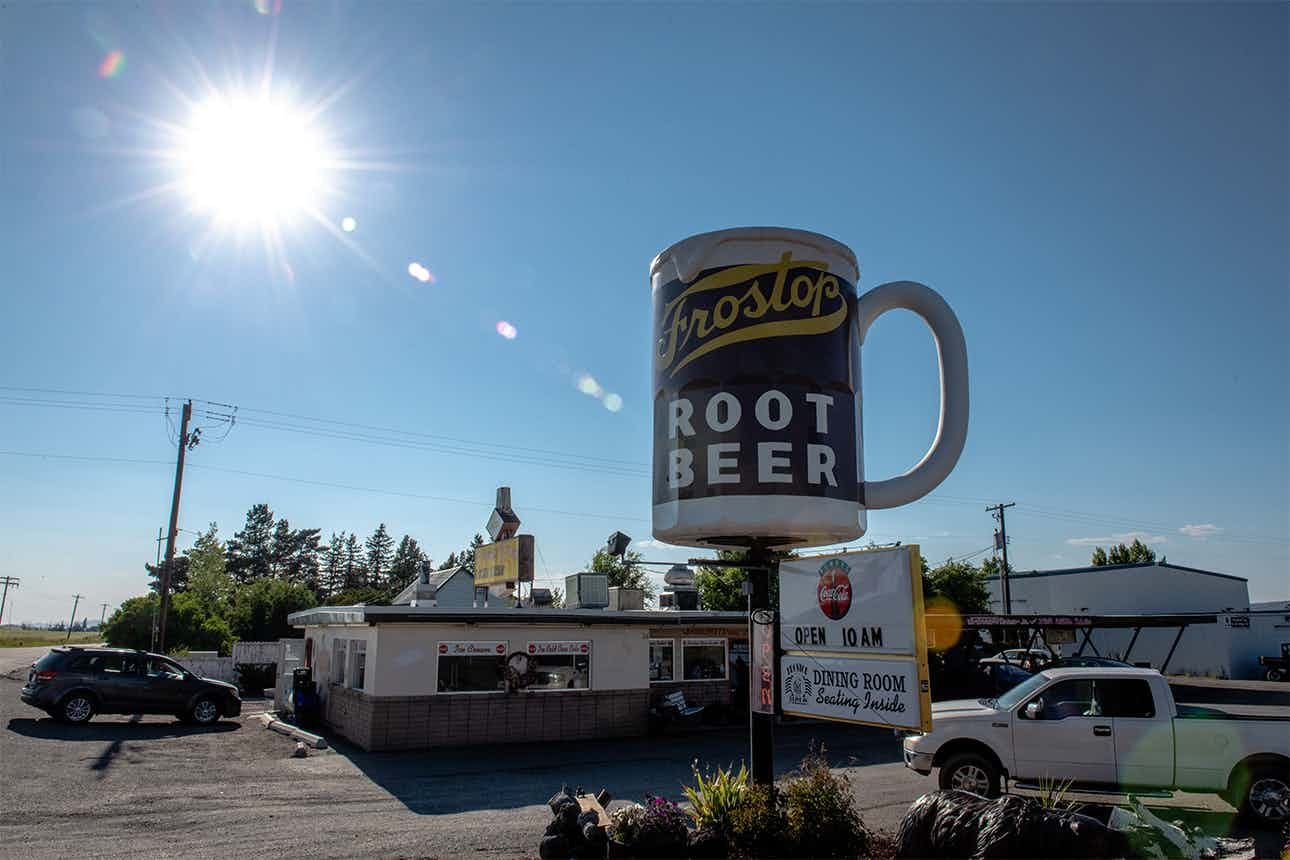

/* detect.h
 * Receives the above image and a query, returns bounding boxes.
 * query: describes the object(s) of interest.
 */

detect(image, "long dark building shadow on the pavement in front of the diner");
[329,723,900,815]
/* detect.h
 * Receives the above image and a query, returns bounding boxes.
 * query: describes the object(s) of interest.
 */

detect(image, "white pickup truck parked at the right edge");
[904,668,1290,825]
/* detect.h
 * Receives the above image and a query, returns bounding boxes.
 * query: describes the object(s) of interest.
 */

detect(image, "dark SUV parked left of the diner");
[21,646,241,726]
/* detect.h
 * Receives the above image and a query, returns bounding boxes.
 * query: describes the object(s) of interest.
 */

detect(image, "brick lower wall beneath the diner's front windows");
[325,685,645,750]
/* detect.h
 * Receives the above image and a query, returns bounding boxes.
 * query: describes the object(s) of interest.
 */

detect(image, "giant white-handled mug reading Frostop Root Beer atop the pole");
[650,228,968,548]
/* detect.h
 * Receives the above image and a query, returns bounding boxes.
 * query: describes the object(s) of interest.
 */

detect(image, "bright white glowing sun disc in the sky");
[178,95,332,228]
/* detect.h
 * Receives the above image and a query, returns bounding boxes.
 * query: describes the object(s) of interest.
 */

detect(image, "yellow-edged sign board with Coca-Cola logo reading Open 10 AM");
[779,544,931,731]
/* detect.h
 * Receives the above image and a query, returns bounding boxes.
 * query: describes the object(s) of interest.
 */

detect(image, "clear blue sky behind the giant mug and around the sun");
[0,0,1290,620]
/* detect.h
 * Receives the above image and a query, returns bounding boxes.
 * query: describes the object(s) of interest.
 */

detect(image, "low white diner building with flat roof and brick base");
[290,601,748,750]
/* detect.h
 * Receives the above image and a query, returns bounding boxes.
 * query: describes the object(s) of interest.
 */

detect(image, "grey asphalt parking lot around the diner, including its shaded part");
[0,649,1275,857]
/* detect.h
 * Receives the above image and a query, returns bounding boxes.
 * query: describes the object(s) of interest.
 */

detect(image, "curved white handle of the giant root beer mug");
[855,281,968,511]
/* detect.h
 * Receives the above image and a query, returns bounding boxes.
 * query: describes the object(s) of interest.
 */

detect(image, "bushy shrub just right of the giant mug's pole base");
[783,748,868,857]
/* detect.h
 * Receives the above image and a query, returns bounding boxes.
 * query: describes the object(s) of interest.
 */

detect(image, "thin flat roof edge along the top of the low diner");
[286,606,748,627]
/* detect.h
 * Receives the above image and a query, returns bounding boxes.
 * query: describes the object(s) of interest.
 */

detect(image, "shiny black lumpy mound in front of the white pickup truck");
[895,790,1133,860]
